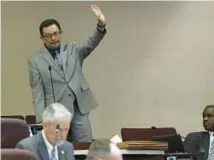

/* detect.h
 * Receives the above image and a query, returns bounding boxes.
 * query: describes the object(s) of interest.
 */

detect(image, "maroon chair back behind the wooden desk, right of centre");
[121,127,177,141]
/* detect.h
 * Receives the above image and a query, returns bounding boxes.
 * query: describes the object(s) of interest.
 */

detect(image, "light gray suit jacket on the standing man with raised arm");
[28,30,106,123]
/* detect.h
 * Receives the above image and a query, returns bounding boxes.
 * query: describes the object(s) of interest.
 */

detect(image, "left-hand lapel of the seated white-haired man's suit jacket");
[37,132,50,160]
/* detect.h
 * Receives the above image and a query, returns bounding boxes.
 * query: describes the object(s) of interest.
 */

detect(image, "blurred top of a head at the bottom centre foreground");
[86,140,123,160]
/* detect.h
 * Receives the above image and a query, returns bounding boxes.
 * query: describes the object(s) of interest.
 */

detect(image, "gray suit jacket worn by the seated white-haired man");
[16,132,75,160]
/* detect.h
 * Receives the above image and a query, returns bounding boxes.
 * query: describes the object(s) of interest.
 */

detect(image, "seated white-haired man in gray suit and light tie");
[16,103,75,160]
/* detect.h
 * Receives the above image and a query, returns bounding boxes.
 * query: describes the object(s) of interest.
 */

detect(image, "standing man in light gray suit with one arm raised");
[28,5,106,142]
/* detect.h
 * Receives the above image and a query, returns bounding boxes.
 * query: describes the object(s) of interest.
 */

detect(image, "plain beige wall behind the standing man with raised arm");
[2,2,214,138]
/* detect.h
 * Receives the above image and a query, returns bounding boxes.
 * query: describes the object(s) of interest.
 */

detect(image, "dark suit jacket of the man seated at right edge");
[184,132,210,159]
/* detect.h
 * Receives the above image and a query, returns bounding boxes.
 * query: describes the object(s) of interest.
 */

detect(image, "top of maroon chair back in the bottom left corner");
[1,148,36,160]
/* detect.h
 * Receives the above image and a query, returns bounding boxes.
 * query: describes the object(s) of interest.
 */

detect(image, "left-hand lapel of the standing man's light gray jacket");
[40,47,64,78]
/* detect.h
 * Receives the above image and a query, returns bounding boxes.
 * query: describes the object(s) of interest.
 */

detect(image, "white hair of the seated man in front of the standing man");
[43,103,72,122]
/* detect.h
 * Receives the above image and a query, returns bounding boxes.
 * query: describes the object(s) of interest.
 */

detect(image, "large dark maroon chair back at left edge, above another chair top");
[1,118,30,148]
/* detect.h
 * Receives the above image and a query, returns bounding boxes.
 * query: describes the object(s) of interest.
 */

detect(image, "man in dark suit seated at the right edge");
[184,105,214,160]
